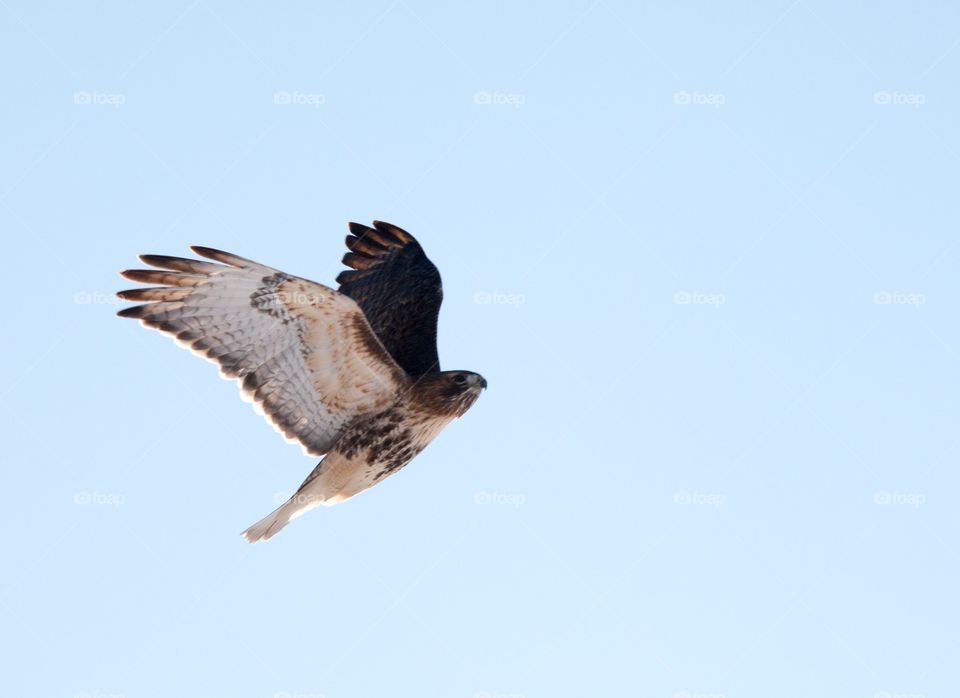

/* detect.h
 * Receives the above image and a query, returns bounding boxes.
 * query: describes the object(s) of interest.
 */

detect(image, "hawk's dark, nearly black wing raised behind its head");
[337,221,443,378]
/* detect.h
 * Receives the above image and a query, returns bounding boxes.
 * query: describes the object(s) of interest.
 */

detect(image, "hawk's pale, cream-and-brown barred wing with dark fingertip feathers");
[117,247,410,456]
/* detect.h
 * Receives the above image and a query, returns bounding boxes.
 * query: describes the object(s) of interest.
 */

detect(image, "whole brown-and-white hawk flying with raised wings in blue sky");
[117,221,487,543]
